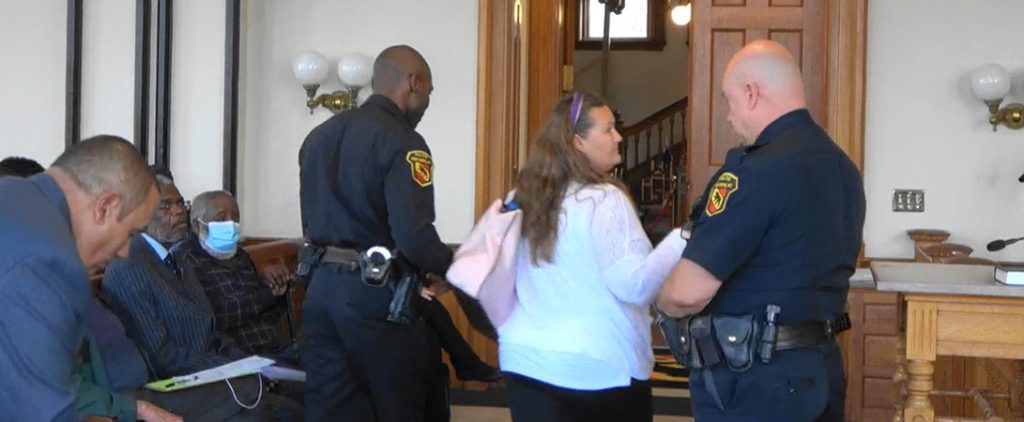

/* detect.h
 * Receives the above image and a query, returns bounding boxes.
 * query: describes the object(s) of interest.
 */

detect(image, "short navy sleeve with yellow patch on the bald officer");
[683,162,792,282]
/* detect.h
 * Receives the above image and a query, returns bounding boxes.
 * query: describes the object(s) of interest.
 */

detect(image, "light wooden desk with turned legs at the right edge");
[871,263,1024,422]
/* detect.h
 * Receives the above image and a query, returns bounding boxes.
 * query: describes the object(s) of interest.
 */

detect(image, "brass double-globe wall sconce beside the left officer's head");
[292,51,374,115]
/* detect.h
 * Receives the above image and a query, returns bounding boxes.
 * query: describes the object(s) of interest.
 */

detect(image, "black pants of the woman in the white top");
[505,372,654,422]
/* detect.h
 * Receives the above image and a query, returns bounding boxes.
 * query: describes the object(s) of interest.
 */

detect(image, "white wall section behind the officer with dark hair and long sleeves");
[240,0,477,242]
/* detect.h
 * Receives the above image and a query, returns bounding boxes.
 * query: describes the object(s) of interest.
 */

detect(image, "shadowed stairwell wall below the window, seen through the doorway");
[573,15,689,125]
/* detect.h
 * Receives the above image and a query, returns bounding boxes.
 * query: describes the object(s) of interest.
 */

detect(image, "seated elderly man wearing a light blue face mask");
[174,191,299,358]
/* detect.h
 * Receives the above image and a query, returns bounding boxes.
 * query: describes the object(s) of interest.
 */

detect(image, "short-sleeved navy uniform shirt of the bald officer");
[683,109,864,324]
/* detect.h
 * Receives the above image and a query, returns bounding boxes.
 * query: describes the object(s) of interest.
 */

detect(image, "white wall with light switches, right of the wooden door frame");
[864,0,1024,260]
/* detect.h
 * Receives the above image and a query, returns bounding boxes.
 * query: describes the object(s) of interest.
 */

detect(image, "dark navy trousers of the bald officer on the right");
[690,342,846,422]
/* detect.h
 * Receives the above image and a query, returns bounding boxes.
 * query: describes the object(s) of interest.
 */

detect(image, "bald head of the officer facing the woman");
[722,40,807,140]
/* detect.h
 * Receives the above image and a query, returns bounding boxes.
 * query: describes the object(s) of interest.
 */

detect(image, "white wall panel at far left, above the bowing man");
[0,0,68,162]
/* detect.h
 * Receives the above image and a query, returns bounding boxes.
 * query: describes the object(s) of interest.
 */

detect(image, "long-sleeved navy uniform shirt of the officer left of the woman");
[299,95,452,275]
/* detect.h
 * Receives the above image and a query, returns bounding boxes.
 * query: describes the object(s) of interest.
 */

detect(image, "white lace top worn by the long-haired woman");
[499,184,686,390]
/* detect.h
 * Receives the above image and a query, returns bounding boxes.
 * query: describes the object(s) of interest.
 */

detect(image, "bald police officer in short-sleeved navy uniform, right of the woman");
[657,40,864,421]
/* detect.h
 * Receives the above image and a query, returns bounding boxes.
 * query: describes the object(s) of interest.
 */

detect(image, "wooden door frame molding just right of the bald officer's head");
[825,0,868,172]
